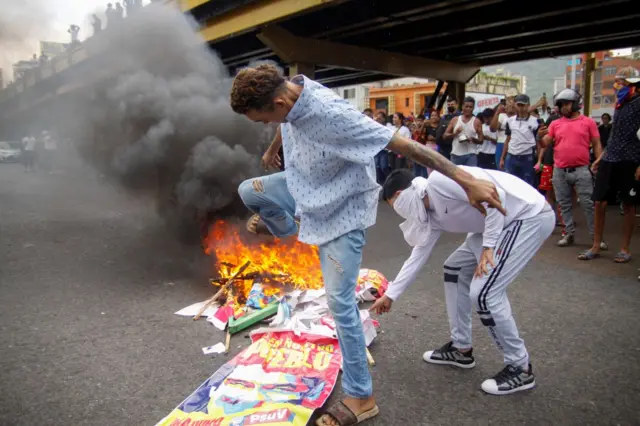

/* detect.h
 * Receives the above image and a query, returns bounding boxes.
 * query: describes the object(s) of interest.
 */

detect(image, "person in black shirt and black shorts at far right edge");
[580,67,640,263]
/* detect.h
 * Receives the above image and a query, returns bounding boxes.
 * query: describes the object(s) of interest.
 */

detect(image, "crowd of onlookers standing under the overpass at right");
[364,69,640,263]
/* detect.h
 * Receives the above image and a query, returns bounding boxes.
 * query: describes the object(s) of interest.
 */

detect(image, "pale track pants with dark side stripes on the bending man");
[444,208,555,370]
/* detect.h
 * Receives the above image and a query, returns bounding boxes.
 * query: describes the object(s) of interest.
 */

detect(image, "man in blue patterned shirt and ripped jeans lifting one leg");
[231,64,504,426]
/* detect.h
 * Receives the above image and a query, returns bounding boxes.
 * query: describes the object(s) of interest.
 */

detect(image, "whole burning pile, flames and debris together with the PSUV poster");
[166,225,388,426]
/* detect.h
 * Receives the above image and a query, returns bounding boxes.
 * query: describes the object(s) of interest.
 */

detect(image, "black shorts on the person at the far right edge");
[591,161,640,205]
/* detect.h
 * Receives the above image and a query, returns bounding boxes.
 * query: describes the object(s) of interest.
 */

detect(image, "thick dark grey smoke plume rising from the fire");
[45,6,269,241]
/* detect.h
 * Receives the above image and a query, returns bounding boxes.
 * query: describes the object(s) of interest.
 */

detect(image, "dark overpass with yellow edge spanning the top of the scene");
[0,0,640,123]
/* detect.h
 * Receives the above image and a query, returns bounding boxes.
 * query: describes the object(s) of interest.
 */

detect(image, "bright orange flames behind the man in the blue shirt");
[204,220,323,306]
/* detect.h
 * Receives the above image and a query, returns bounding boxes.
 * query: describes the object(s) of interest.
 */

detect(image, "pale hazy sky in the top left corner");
[0,0,132,79]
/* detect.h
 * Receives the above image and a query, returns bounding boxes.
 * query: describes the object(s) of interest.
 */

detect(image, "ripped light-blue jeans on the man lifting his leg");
[238,173,372,398]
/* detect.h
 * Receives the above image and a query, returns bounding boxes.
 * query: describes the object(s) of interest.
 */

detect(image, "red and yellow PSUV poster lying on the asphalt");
[158,331,342,426]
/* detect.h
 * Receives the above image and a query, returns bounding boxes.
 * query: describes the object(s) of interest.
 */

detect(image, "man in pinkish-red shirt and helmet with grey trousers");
[542,89,602,247]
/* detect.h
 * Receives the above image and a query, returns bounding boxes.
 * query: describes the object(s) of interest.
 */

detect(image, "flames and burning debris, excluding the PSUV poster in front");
[176,220,388,342]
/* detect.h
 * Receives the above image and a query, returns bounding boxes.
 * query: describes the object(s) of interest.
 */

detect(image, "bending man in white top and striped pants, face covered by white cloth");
[371,167,555,395]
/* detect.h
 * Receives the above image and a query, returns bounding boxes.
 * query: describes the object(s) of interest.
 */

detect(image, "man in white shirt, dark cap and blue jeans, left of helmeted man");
[500,94,539,186]
